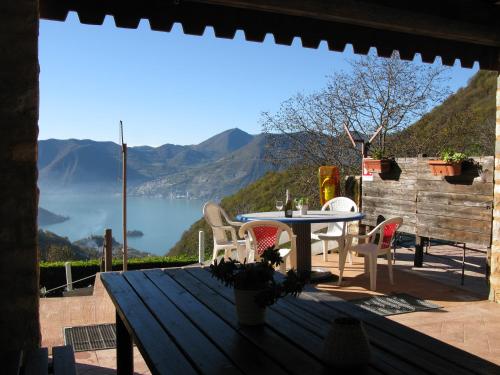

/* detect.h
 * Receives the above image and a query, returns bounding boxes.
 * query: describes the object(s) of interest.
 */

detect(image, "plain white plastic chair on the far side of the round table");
[311,197,358,264]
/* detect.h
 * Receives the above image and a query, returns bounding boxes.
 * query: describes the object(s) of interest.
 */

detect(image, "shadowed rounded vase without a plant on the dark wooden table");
[322,317,371,368]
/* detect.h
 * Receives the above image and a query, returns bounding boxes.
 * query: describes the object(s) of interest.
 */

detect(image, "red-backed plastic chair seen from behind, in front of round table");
[239,220,297,273]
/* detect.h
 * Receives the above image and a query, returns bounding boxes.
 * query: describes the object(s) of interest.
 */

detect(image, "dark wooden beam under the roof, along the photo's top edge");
[189,0,500,47]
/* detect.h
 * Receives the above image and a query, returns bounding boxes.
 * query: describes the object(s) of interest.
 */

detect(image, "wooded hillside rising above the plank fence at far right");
[388,71,497,156]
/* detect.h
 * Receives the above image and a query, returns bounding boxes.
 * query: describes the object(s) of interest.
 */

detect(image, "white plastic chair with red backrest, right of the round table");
[339,217,403,290]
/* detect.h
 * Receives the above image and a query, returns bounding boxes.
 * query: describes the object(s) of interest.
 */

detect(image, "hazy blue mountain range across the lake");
[38,128,273,198]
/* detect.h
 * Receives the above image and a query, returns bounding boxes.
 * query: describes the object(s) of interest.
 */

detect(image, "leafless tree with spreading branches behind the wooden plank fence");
[262,53,449,167]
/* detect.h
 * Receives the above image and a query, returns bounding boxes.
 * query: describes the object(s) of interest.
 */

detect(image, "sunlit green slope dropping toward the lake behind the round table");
[168,170,319,256]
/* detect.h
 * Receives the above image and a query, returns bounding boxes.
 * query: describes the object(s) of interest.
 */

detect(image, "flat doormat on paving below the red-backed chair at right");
[348,293,441,316]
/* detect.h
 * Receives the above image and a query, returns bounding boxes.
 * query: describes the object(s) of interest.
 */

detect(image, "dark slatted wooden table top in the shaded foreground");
[101,267,500,375]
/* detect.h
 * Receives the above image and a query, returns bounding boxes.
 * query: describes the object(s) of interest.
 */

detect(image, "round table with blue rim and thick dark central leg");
[236,211,365,282]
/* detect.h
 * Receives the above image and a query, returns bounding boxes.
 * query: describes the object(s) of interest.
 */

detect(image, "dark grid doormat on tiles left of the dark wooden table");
[63,323,116,352]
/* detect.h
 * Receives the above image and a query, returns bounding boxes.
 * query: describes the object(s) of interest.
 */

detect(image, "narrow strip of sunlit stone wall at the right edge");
[490,75,500,303]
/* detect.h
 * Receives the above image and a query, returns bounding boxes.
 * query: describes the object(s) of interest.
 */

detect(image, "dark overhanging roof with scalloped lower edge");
[40,0,500,70]
